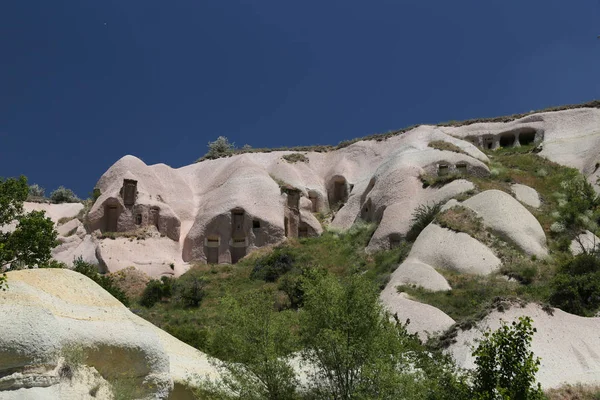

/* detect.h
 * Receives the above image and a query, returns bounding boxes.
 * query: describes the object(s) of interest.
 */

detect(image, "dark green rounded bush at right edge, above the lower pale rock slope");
[550,253,600,316]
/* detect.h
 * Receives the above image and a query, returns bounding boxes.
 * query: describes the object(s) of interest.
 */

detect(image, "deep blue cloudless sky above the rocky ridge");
[0,0,600,196]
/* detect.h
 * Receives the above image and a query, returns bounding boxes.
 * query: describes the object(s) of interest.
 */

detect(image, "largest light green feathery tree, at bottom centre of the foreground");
[300,275,427,400]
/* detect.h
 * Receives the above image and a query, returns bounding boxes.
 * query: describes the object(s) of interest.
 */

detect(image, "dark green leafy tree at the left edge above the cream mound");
[0,176,58,288]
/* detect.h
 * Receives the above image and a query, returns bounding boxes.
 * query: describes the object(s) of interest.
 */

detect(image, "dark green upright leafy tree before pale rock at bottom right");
[473,317,544,400]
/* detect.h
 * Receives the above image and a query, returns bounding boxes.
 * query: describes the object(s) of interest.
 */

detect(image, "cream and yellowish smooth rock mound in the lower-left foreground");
[0,269,214,399]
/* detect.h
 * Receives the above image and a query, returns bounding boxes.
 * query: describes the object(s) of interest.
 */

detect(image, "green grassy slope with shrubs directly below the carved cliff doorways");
[133,223,410,356]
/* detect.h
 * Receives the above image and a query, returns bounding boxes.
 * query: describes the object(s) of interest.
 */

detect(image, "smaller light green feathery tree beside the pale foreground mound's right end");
[197,290,297,400]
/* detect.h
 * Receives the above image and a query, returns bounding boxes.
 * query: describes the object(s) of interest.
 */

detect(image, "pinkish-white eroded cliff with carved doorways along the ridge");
[48,108,600,276]
